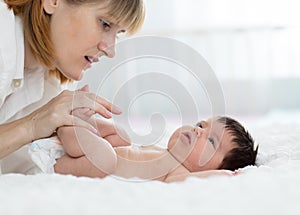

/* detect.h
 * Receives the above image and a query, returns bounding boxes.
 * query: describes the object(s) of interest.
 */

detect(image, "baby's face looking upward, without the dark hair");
[168,119,234,172]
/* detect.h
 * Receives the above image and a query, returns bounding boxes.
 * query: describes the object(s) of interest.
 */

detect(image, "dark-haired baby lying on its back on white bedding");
[31,109,257,182]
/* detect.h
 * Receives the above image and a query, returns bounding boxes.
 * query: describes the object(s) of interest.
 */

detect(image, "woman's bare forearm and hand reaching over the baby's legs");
[0,86,121,158]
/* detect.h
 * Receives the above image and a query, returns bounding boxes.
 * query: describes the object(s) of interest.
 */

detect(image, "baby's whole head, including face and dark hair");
[168,117,257,172]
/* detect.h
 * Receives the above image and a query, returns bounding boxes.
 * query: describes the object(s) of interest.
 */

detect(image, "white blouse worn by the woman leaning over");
[0,0,62,173]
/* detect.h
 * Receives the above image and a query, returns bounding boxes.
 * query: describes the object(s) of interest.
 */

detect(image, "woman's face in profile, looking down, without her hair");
[44,0,124,80]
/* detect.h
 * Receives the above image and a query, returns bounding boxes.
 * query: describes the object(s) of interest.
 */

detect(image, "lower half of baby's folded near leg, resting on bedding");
[54,154,108,178]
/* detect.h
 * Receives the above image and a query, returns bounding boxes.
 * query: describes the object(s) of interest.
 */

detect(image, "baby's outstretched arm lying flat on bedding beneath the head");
[165,169,236,183]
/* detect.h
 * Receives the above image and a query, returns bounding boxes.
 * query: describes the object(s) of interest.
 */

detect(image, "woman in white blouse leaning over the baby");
[0,0,144,173]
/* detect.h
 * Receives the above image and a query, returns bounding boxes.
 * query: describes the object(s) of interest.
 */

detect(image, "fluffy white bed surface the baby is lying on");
[0,113,300,215]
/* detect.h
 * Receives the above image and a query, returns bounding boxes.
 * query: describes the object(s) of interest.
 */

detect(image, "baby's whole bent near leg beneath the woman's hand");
[54,127,117,177]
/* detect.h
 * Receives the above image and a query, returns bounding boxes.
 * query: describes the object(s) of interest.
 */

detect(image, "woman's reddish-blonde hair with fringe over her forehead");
[4,0,145,83]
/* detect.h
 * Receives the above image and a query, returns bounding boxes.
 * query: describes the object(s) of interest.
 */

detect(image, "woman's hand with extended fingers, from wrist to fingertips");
[28,86,121,140]
